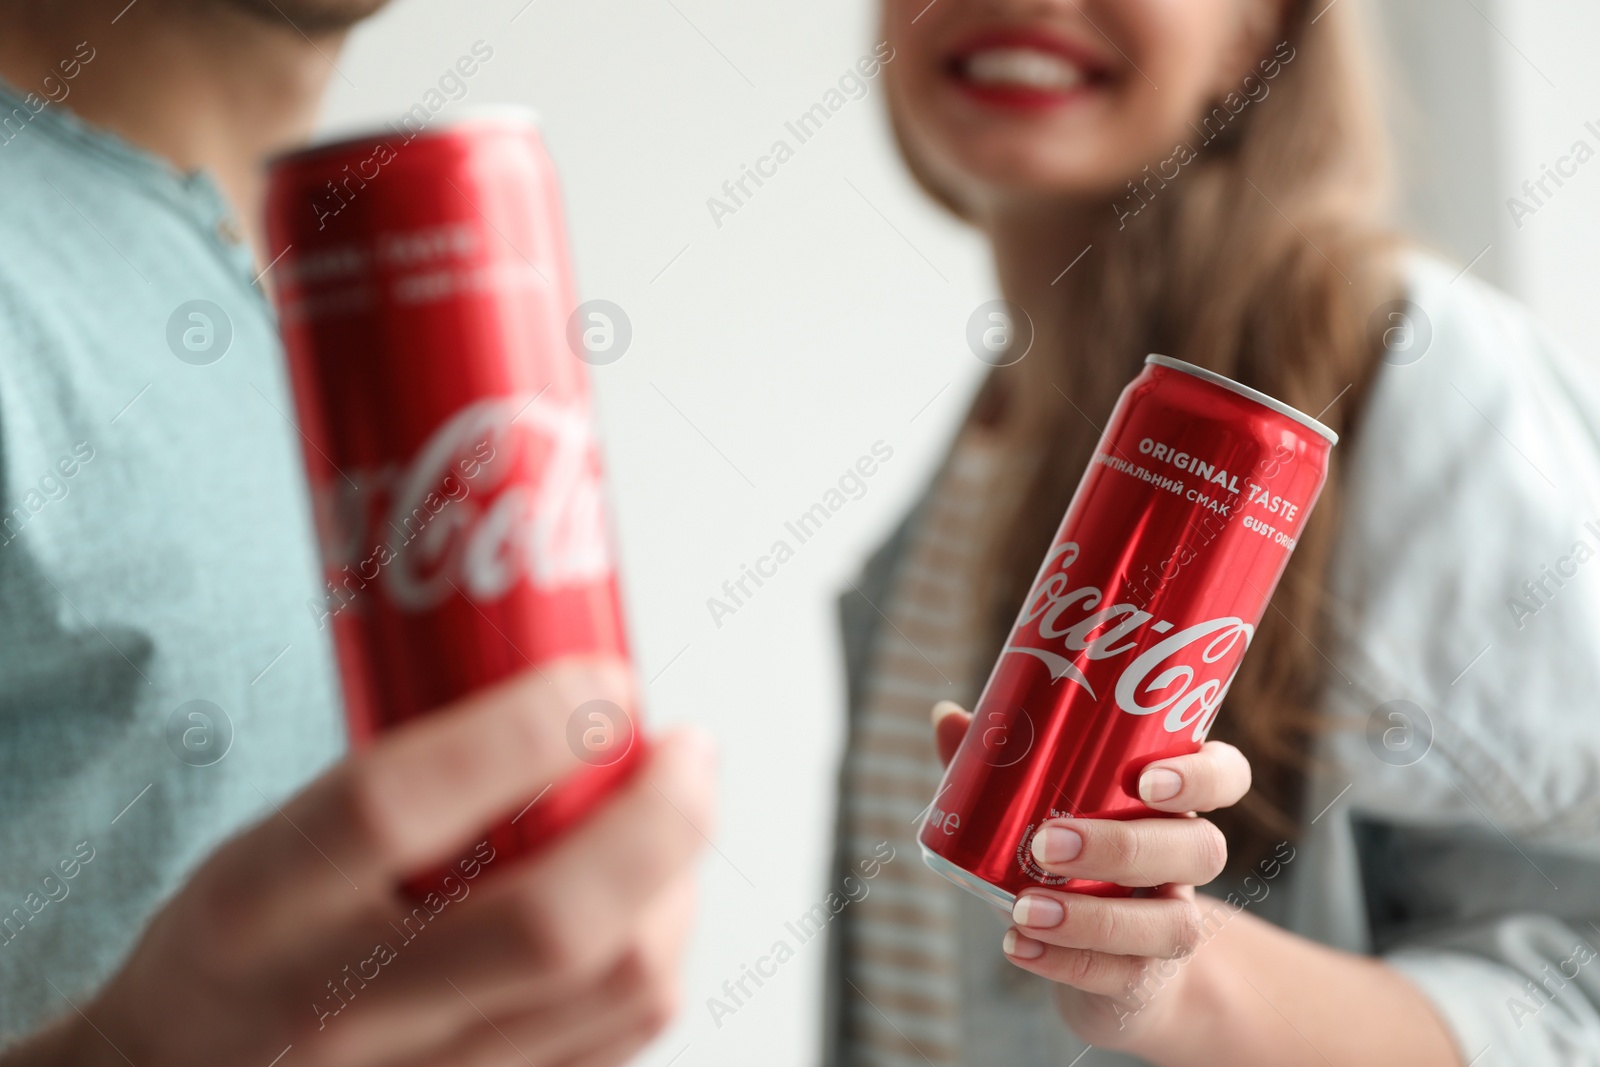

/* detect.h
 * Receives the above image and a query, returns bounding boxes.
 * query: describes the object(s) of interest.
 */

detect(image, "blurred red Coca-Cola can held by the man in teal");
[267,109,643,888]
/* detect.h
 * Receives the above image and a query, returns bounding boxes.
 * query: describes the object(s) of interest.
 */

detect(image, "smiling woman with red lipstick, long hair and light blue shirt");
[830,0,1600,1067]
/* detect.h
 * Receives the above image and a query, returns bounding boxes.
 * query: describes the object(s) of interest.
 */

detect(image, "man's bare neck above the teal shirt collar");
[0,0,342,254]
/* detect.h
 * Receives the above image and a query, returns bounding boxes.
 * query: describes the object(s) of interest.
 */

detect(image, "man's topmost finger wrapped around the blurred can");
[197,659,634,957]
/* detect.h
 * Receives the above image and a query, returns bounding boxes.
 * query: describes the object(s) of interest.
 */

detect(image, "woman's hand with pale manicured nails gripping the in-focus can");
[933,702,1250,1048]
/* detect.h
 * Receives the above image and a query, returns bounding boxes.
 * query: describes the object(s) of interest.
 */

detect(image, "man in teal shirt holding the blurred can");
[0,0,710,1067]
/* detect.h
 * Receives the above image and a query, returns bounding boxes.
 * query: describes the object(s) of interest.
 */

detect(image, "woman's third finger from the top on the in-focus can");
[1011,889,1205,960]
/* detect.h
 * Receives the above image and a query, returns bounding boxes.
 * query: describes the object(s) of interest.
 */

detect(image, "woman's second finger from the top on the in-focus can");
[1030,819,1227,888]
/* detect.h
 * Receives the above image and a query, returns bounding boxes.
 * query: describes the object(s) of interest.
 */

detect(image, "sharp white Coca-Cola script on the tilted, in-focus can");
[1002,541,1256,741]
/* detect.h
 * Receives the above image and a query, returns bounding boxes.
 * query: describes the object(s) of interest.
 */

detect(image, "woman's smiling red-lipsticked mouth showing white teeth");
[947,29,1106,109]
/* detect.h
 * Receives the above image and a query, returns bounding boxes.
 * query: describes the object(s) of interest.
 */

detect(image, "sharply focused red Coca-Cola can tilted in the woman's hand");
[920,355,1338,909]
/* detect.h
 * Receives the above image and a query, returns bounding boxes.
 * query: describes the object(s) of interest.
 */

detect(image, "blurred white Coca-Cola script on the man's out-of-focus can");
[312,395,611,621]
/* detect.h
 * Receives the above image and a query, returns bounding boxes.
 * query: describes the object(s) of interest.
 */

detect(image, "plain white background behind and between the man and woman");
[325,0,1600,1067]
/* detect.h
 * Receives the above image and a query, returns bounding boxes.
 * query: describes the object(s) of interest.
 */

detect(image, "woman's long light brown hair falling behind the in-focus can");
[890,0,1402,870]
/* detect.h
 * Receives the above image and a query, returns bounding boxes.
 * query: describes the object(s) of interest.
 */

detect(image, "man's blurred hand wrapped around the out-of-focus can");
[20,661,712,1067]
